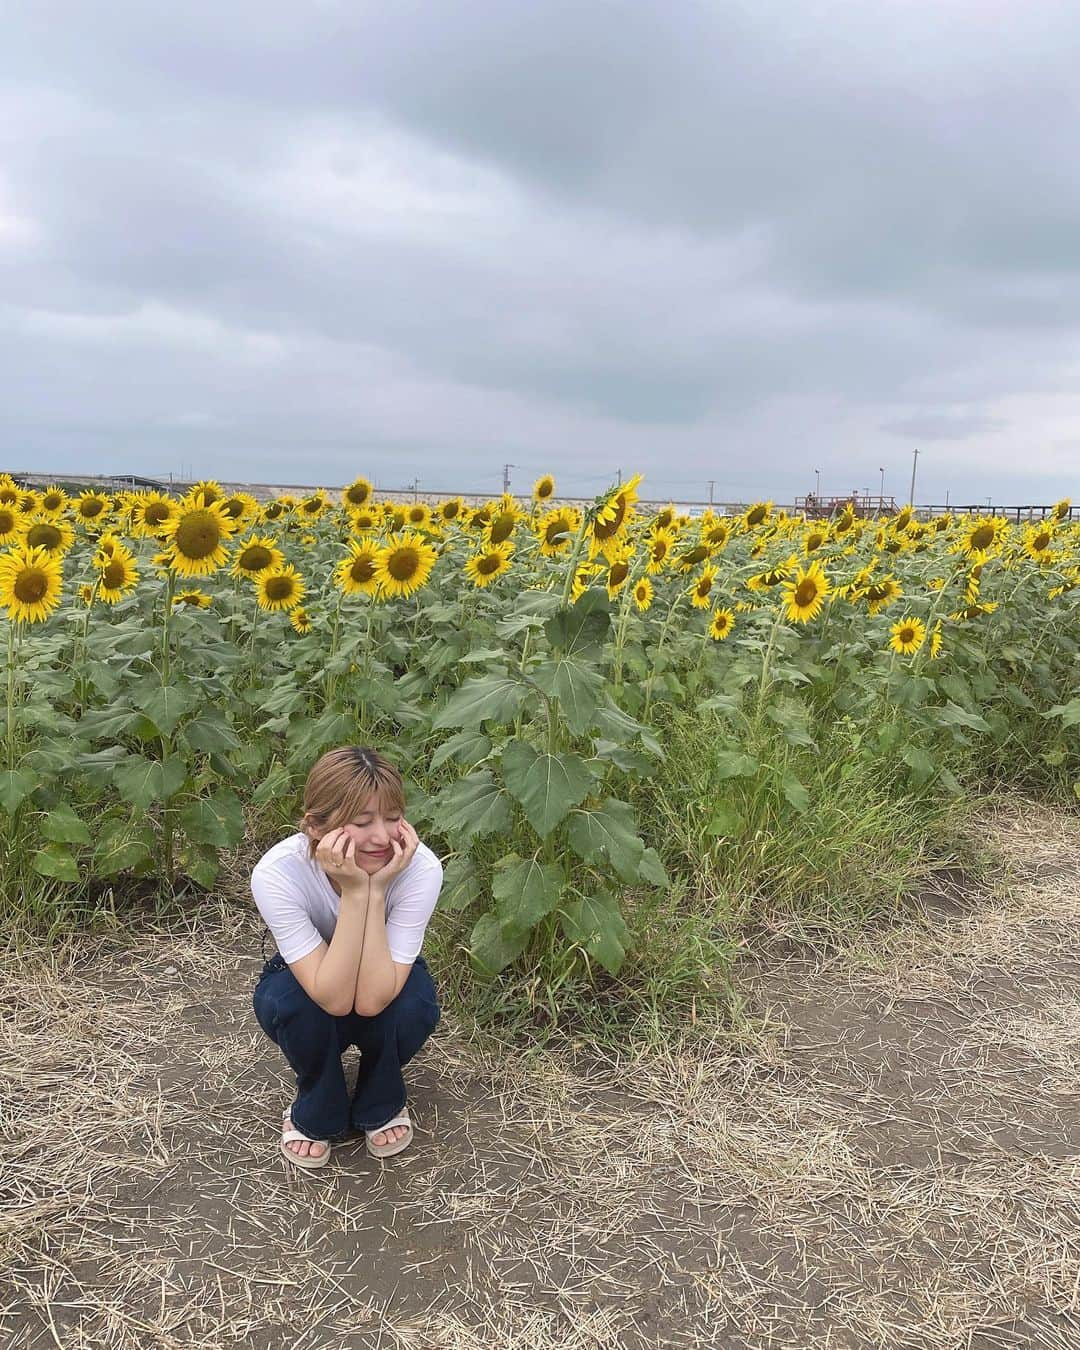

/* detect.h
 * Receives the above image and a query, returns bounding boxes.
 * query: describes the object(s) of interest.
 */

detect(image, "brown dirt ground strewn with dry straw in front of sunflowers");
[0,803,1080,1350]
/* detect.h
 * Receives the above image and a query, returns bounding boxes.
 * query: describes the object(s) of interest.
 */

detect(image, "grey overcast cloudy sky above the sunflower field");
[0,0,1080,504]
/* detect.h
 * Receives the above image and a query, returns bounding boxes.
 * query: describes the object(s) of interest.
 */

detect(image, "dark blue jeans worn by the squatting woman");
[251,952,440,1139]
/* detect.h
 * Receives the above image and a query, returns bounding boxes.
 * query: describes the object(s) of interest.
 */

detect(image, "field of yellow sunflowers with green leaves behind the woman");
[0,475,1080,979]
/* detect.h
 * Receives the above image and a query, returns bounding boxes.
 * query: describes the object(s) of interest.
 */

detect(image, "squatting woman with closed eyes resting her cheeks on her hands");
[251,745,443,1168]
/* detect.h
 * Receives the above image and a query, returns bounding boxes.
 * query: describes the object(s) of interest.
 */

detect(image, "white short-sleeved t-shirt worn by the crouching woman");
[251,833,443,964]
